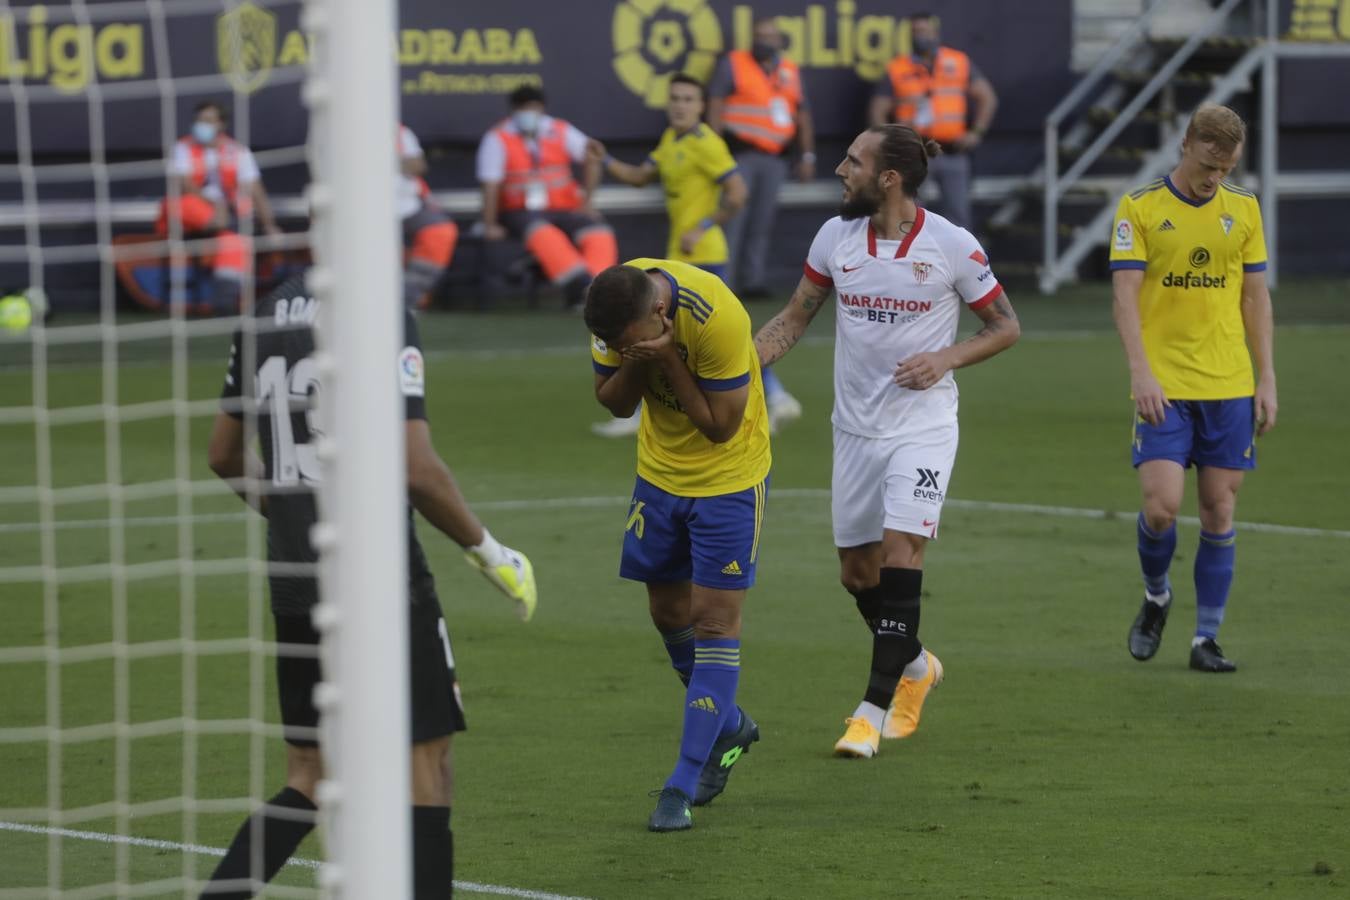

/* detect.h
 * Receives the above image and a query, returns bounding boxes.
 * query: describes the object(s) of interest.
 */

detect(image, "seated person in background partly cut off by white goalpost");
[396,125,459,309]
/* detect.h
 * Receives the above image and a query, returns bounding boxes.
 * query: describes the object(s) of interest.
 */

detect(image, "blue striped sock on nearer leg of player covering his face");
[666,638,741,797]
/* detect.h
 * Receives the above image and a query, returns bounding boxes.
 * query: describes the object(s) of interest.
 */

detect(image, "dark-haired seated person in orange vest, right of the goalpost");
[478,85,618,309]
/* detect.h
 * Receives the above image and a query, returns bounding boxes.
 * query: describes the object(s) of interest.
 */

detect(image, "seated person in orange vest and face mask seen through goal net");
[155,100,281,314]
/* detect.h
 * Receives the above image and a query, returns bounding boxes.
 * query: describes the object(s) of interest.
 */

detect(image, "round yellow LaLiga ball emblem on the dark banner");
[612,0,722,109]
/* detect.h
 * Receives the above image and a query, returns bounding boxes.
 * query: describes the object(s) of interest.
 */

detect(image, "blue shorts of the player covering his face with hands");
[618,478,768,591]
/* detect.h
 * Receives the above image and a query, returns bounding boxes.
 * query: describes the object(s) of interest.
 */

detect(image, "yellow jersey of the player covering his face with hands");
[591,258,771,497]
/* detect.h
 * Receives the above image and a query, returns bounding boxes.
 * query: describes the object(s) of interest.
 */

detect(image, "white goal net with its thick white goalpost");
[0,0,408,897]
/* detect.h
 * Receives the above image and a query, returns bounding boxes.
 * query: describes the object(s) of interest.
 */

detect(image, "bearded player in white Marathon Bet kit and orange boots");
[755,125,1021,758]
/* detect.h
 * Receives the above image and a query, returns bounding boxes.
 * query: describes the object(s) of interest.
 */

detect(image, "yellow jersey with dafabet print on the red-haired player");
[1111,177,1266,399]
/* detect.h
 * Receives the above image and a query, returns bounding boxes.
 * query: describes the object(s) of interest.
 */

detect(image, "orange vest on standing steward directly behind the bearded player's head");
[722,50,802,154]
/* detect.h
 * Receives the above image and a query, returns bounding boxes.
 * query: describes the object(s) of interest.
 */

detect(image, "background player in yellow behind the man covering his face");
[591,73,802,437]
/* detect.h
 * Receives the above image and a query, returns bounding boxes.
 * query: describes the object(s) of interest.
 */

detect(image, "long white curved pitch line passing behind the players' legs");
[0,487,1350,538]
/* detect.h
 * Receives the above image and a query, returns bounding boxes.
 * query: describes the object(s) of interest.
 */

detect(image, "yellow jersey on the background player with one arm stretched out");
[647,124,736,264]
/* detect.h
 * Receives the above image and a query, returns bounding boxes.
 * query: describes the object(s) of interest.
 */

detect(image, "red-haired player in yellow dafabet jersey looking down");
[1111,104,1277,672]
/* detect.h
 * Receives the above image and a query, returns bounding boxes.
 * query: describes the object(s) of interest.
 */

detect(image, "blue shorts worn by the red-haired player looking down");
[1131,397,1257,468]
